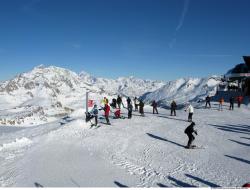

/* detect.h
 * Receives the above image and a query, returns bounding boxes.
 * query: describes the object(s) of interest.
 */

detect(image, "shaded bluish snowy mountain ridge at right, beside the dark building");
[142,76,221,107]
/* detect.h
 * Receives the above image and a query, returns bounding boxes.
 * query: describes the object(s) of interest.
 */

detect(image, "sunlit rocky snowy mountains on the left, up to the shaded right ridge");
[0,65,164,125]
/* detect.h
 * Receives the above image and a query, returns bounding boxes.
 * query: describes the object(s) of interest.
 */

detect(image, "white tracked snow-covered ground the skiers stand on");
[0,103,250,187]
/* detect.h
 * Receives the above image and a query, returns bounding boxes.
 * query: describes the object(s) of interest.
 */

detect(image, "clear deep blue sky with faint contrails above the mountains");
[0,0,250,81]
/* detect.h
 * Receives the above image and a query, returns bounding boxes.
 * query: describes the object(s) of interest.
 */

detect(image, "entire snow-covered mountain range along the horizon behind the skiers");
[0,65,221,125]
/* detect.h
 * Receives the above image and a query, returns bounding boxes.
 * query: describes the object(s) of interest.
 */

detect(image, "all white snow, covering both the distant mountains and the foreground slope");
[0,66,250,187]
